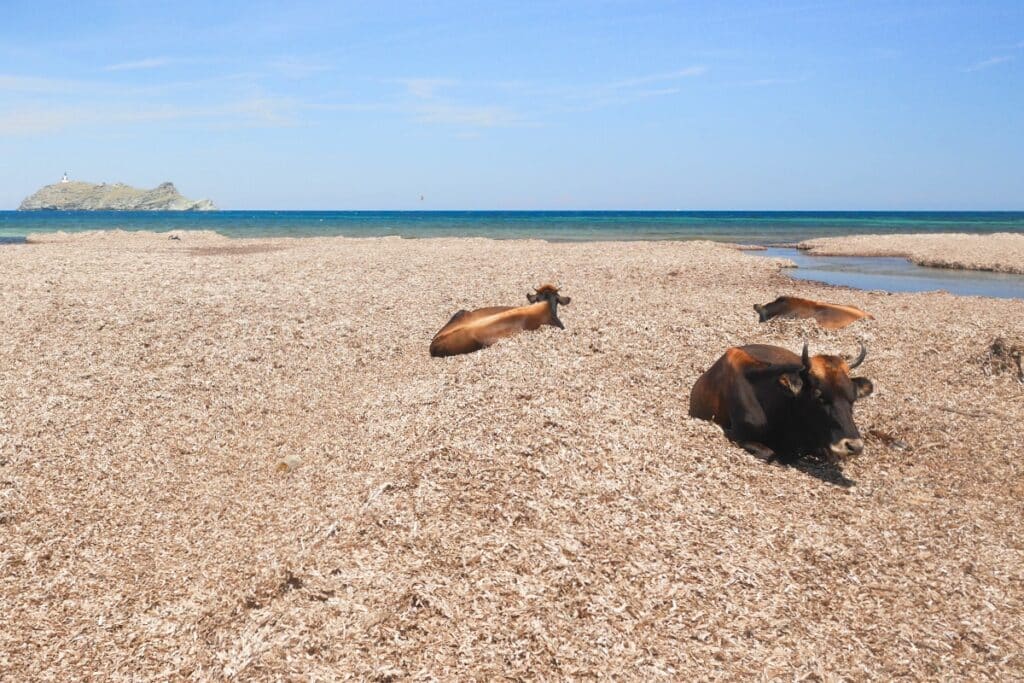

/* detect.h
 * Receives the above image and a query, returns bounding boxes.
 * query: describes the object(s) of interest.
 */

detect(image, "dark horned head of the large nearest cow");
[799,344,874,460]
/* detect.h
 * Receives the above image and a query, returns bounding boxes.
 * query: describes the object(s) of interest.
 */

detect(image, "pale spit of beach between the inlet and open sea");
[797,232,1024,273]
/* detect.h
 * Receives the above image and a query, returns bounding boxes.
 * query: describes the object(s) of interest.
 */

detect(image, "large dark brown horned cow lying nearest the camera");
[690,344,874,462]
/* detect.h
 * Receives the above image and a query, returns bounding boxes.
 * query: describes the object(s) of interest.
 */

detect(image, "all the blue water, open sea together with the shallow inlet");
[0,211,1024,298]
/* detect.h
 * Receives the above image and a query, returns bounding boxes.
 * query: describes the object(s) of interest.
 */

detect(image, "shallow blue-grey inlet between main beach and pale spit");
[765,249,1024,298]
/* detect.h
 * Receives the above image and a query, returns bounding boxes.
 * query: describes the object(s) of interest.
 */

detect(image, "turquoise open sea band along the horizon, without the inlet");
[0,211,1024,245]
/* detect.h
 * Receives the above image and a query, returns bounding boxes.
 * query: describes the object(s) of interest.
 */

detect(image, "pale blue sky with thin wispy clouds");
[0,0,1024,210]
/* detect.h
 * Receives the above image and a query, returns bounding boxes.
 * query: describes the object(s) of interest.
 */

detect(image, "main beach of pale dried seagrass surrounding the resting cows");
[6,232,1024,681]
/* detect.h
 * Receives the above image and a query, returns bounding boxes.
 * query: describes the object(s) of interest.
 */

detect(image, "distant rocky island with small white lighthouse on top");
[18,179,217,211]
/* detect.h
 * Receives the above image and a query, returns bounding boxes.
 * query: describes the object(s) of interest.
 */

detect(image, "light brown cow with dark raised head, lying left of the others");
[430,285,571,356]
